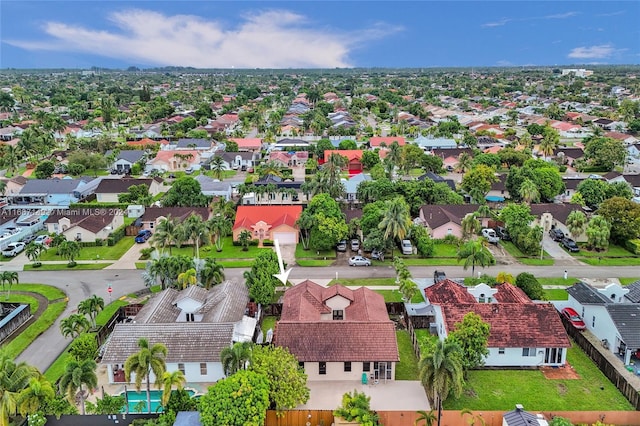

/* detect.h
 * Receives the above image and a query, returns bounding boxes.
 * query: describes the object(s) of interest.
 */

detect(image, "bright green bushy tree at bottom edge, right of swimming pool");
[199,370,269,426]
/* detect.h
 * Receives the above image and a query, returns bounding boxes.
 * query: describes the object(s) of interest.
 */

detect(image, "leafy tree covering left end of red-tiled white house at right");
[448,312,491,369]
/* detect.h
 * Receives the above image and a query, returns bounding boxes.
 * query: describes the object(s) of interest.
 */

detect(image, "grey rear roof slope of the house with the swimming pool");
[102,322,233,364]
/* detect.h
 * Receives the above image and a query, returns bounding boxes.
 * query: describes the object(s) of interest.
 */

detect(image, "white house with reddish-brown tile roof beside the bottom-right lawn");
[425,279,571,367]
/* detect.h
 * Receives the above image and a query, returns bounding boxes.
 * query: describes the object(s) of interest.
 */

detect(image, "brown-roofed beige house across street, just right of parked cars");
[418,204,488,239]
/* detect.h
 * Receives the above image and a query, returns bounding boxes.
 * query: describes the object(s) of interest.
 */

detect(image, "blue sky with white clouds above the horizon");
[0,0,640,69]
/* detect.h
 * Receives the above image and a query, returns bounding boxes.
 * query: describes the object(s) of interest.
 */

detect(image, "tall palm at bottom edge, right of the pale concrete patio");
[418,339,464,425]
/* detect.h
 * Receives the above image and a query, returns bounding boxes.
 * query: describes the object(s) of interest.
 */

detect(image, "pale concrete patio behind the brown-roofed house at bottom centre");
[298,380,431,411]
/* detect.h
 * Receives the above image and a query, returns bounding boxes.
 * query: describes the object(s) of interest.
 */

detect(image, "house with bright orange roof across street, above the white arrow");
[233,205,302,244]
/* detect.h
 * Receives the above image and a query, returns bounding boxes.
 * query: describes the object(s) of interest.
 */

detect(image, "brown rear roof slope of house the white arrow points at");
[274,321,400,362]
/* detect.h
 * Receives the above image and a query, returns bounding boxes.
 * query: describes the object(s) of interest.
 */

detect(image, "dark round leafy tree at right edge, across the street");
[598,197,640,244]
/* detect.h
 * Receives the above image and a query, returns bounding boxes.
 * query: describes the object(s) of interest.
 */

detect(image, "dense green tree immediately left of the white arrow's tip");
[244,250,282,305]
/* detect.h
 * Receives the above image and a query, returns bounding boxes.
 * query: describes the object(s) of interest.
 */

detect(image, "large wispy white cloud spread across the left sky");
[5,9,402,68]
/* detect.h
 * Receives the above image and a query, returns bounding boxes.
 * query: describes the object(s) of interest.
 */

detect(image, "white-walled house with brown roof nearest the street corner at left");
[44,208,124,242]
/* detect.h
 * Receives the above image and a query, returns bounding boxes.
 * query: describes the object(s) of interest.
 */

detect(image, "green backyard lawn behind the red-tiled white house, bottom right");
[444,345,633,411]
